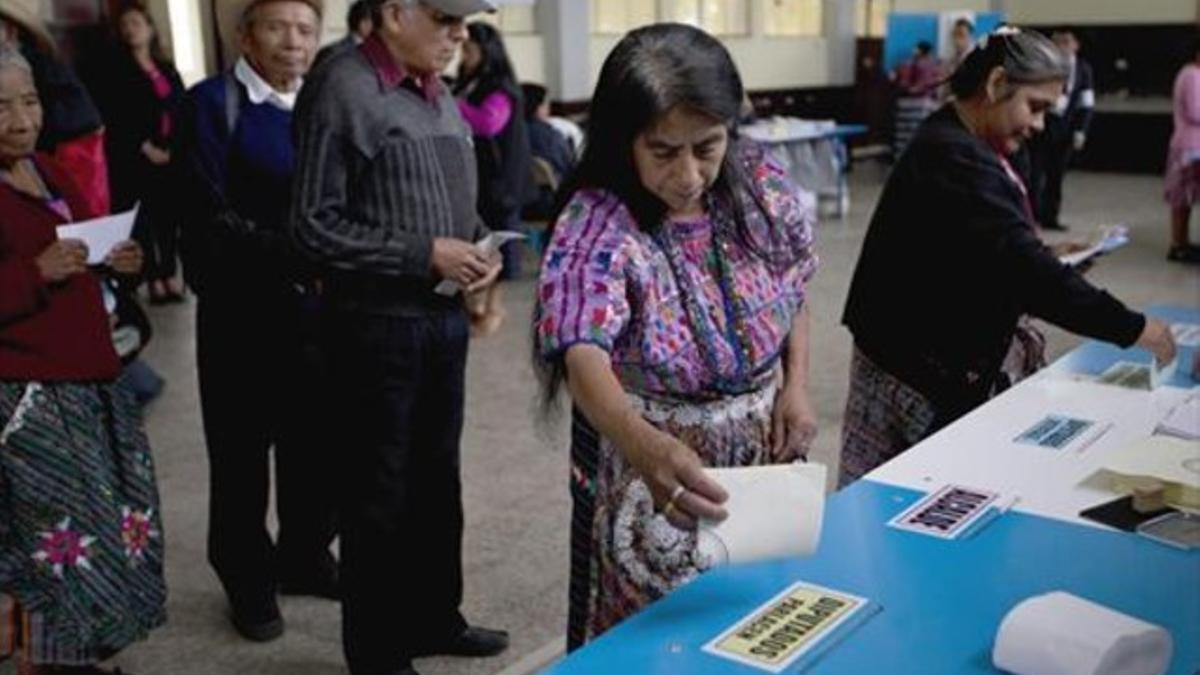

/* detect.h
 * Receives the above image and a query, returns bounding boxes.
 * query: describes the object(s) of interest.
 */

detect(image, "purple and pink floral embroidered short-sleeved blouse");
[534,144,817,400]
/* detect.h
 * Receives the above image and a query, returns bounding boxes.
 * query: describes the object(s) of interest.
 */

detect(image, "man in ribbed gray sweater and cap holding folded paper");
[290,0,508,675]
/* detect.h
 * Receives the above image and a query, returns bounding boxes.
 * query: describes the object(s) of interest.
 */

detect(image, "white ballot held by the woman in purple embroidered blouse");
[697,462,826,565]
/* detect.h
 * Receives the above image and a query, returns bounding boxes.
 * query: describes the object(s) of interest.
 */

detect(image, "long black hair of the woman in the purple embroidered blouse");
[534,23,787,411]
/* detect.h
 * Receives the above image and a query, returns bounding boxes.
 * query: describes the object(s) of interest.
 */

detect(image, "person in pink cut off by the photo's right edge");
[1165,36,1200,264]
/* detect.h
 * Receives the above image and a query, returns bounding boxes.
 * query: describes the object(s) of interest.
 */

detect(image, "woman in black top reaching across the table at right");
[840,28,1175,485]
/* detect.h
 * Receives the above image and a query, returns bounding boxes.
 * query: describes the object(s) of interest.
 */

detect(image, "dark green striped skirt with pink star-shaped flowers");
[0,381,167,665]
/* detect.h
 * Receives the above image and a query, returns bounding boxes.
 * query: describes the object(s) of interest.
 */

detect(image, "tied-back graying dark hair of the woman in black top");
[950,28,1070,100]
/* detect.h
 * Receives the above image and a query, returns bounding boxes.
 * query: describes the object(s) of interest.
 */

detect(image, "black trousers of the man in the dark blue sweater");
[196,292,337,605]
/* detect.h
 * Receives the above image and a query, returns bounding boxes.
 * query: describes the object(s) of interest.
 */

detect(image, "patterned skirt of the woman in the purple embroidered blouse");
[568,383,778,650]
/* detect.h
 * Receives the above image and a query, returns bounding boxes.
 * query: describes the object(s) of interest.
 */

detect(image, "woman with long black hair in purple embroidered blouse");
[534,24,816,649]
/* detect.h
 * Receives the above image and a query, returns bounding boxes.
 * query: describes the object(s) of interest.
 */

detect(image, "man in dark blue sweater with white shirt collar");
[179,0,337,641]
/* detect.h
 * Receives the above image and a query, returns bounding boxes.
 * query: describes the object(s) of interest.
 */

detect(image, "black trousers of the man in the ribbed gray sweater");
[326,306,469,675]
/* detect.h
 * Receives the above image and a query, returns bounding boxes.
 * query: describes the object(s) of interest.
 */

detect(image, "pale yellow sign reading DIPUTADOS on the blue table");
[704,581,866,673]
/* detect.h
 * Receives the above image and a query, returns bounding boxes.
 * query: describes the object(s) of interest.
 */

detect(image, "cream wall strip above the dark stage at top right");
[1006,0,1198,24]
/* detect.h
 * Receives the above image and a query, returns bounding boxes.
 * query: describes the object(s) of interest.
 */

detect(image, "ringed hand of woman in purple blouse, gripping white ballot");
[629,431,730,530]
